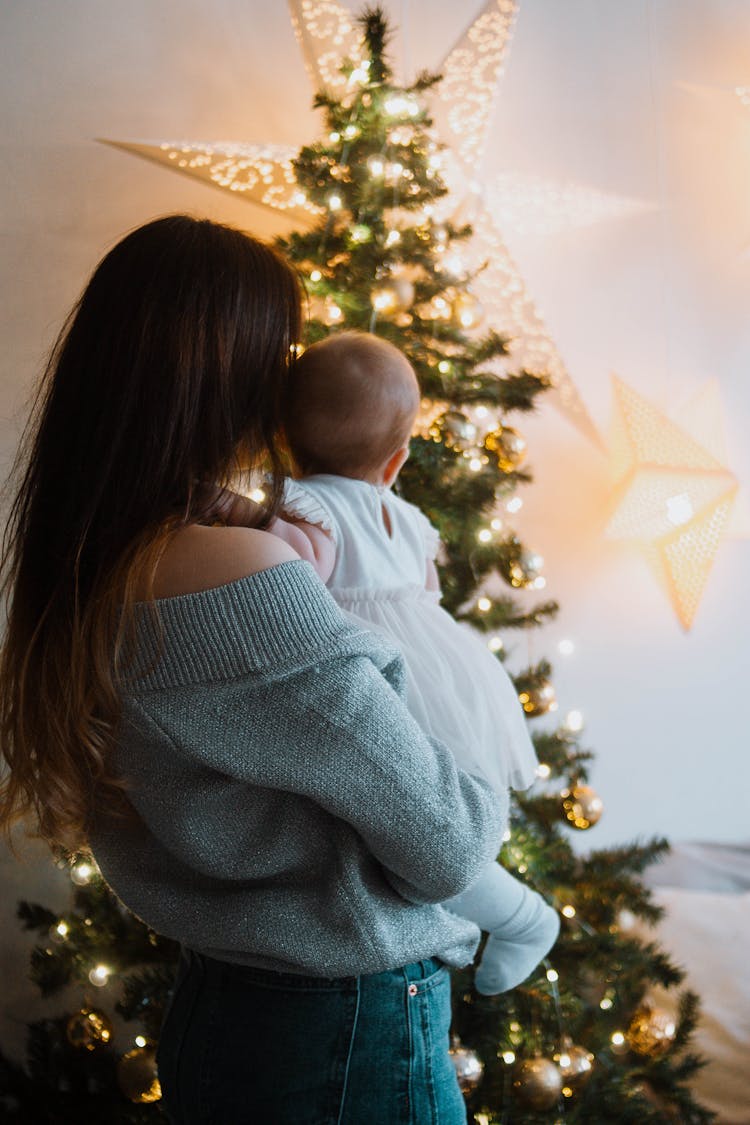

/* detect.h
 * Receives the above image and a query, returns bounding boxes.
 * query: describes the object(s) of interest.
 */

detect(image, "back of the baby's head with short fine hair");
[284,332,419,484]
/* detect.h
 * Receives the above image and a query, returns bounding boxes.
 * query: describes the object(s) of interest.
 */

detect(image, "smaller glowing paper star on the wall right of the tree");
[606,377,739,629]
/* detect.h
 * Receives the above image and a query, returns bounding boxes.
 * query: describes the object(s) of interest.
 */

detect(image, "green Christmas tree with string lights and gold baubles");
[0,9,712,1125]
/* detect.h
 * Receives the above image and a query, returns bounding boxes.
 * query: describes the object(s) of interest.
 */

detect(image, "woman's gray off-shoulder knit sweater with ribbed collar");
[91,561,506,977]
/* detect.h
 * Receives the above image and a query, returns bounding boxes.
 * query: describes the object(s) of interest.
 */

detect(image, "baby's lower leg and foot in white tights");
[444,863,560,996]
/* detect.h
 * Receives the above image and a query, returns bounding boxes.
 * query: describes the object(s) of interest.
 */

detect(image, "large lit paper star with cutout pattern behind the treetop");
[105,0,648,444]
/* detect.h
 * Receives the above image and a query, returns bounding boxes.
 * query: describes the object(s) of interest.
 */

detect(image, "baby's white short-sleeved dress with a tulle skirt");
[282,474,536,792]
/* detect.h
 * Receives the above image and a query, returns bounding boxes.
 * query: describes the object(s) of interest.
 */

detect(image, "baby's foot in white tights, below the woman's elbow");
[475,894,560,996]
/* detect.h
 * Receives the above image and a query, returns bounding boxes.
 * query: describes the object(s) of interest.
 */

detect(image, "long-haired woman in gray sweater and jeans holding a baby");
[0,216,503,1125]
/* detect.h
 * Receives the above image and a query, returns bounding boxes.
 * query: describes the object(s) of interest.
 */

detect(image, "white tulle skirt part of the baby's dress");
[333,586,536,792]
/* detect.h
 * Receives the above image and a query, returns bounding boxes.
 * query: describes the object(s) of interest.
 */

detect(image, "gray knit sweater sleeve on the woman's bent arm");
[188,651,507,902]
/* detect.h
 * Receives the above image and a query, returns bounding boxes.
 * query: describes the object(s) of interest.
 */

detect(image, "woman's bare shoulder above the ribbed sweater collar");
[149,524,299,597]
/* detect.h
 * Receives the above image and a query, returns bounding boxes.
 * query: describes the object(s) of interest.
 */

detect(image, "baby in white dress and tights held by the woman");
[222,332,560,995]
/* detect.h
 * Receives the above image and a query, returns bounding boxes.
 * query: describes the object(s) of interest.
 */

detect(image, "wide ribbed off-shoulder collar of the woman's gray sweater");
[124,559,353,692]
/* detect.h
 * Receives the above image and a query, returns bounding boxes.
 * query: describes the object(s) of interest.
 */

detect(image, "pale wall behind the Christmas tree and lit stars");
[0,0,750,1062]
